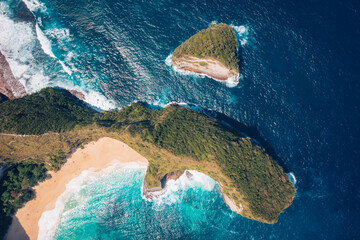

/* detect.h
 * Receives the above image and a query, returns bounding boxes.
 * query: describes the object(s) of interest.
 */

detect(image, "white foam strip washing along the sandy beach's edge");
[38,160,146,240]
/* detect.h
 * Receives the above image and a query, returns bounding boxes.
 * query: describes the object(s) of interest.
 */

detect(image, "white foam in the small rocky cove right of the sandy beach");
[143,170,216,207]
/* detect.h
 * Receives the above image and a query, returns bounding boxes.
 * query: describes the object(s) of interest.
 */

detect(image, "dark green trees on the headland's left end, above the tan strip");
[0,88,94,134]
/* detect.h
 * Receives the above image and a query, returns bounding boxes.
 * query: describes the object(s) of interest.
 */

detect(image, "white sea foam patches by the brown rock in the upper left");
[0,1,116,110]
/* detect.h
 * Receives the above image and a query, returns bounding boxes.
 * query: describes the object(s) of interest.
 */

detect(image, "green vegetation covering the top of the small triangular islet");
[172,24,239,73]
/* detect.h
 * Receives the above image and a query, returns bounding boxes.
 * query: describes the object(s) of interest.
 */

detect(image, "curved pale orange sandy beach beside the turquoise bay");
[6,137,148,240]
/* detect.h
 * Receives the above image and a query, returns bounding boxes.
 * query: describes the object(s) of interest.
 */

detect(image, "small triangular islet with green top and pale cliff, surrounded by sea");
[172,24,239,81]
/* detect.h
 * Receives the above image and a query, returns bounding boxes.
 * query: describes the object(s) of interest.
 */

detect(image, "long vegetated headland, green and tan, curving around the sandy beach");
[0,88,295,237]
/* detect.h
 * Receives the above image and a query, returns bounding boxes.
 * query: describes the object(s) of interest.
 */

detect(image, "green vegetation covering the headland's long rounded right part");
[95,103,294,222]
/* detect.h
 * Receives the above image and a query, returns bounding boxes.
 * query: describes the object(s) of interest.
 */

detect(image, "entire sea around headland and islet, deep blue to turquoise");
[0,0,360,239]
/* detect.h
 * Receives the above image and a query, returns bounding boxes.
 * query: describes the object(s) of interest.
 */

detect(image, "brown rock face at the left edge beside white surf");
[0,52,26,99]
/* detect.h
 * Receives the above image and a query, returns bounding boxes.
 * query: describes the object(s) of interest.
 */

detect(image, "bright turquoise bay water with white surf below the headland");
[45,168,239,239]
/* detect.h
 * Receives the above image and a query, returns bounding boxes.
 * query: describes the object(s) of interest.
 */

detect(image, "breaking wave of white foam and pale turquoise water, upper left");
[0,0,116,110]
